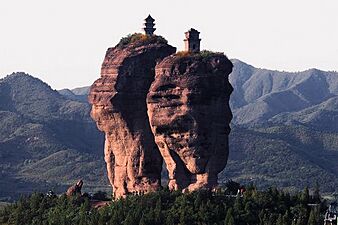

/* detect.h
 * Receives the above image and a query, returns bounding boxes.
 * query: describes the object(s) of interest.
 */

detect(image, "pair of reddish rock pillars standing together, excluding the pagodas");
[89,37,232,198]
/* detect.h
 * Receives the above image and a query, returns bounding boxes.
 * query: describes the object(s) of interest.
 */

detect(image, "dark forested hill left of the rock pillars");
[0,73,107,199]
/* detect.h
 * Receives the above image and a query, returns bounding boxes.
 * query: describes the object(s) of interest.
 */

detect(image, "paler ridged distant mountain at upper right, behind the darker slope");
[230,60,338,131]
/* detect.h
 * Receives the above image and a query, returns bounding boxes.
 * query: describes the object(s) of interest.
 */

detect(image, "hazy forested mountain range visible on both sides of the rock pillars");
[0,60,338,198]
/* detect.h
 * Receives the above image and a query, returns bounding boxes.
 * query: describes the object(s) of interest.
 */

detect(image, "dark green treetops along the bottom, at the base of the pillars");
[0,186,327,225]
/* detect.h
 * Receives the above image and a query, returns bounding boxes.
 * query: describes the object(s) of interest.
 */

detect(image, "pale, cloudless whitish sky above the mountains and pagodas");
[0,0,338,89]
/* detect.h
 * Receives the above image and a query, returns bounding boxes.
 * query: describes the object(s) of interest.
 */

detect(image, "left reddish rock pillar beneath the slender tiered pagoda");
[89,35,176,198]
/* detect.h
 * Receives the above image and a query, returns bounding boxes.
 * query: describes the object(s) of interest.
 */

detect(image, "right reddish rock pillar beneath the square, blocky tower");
[147,53,233,191]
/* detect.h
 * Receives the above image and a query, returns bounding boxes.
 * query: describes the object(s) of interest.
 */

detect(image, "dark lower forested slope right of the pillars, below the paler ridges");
[226,125,338,192]
